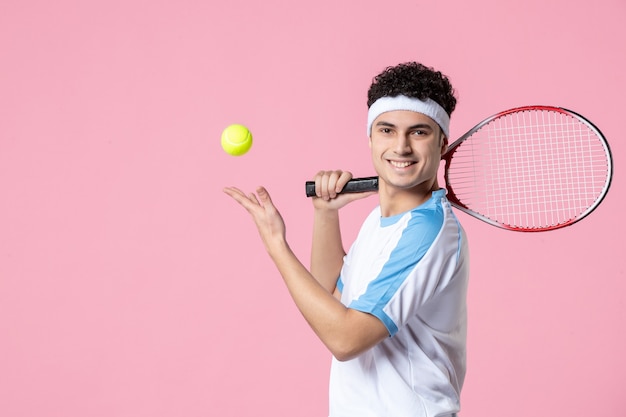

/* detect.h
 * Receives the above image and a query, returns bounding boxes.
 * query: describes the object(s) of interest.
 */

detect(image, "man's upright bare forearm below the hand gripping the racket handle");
[311,209,346,293]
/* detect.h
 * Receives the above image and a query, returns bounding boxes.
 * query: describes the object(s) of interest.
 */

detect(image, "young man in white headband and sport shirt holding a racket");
[224,62,468,417]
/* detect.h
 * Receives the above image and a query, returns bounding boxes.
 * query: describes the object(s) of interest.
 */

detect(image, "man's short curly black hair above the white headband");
[367,62,456,116]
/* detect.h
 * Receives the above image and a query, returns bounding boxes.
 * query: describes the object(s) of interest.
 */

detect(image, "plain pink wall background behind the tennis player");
[0,0,626,417]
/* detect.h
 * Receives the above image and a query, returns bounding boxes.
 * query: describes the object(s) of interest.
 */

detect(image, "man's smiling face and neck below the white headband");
[370,110,447,209]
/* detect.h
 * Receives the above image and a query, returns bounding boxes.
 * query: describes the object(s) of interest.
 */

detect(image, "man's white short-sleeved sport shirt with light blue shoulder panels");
[330,189,469,417]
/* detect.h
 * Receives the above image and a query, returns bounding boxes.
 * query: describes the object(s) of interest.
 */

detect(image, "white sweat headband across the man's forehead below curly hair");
[367,96,450,137]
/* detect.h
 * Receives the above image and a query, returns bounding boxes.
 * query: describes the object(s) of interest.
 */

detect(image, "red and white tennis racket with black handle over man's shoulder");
[306,106,613,232]
